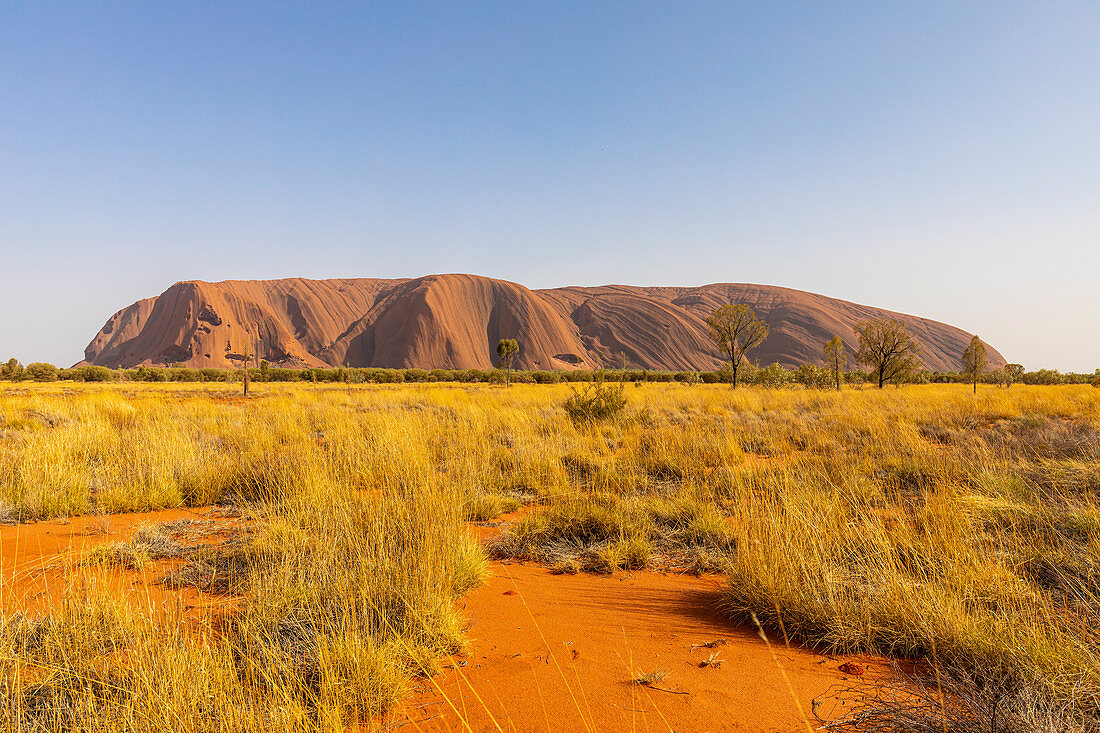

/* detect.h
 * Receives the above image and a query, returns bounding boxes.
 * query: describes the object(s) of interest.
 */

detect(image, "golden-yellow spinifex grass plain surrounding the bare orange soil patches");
[0,384,1100,732]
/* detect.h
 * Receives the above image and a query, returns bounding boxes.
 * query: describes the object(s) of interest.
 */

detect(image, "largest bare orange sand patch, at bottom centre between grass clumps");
[384,519,892,733]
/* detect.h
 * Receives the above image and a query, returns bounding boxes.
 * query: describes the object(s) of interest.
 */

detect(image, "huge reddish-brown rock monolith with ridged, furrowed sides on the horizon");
[84,275,1004,371]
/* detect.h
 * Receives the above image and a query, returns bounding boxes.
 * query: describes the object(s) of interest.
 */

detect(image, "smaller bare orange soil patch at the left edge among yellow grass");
[0,508,242,617]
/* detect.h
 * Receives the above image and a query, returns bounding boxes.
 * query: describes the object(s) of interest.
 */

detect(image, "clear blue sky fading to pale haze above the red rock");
[0,1,1100,371]
